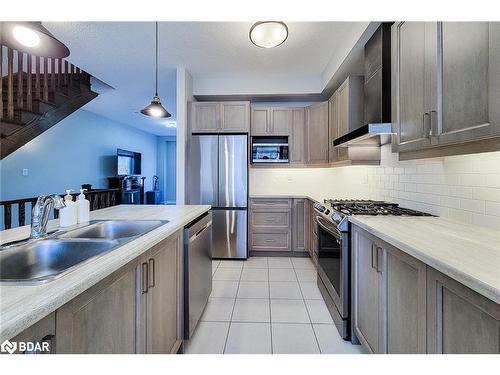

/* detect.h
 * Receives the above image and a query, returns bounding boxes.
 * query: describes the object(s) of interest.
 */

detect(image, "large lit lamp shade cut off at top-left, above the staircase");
[0,22,69,58]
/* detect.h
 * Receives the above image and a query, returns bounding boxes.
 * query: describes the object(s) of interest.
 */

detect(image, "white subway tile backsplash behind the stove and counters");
[250,145,500,230]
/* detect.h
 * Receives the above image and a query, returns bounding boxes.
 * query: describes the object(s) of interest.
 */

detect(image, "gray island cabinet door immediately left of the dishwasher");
[146,234,182,354]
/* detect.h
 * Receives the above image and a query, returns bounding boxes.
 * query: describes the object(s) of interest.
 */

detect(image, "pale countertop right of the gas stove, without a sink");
[349,216,500,304]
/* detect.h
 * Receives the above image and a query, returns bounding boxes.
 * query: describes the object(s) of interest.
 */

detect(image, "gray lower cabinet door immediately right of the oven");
[352,227,385,353]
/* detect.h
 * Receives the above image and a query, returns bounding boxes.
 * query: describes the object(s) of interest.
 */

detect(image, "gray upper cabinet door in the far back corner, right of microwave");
[306,102,328,164]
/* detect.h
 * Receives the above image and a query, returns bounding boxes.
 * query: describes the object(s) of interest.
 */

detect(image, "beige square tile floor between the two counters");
[185,257,362,354]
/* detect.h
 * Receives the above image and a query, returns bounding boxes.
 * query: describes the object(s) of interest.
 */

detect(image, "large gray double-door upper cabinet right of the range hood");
[391,22,500,156]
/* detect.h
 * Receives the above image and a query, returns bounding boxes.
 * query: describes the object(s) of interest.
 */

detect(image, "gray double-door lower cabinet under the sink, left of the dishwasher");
[56,232,182,354]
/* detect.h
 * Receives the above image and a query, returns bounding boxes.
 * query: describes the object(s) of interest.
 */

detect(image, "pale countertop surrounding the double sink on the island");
[0,205,210,342]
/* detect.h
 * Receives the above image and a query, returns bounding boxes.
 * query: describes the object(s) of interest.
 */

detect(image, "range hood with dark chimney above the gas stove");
[333,22,392,147]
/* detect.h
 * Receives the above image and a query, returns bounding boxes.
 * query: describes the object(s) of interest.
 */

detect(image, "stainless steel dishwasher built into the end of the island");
[184,213,212,340]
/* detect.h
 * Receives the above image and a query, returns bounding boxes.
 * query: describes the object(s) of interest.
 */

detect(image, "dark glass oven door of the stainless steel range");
[315,216,349,319]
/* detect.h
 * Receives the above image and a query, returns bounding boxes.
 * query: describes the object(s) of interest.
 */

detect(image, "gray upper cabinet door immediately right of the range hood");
[392,22,437,151]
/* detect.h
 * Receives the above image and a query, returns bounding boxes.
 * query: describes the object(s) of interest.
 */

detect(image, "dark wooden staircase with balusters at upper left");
[0,45,97,159]
